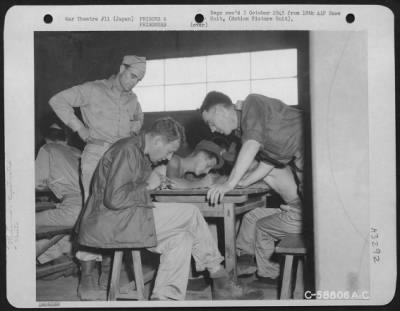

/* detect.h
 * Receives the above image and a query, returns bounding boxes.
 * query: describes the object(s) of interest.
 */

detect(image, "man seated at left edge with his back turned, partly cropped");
[35,124,82,270]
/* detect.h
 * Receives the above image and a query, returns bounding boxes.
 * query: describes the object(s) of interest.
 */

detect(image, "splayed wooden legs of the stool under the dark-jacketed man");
[107,249,155,301]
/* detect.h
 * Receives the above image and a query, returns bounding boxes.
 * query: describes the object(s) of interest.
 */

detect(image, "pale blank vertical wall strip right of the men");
[310,31,370,292]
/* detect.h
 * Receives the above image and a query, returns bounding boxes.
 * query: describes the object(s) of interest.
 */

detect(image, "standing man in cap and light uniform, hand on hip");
[49,55,146,298]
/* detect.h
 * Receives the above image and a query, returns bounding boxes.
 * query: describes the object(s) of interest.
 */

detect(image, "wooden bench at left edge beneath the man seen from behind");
[36,226,75,279]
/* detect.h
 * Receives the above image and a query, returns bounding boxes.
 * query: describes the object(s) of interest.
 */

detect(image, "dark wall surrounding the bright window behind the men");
[34,31,309,152]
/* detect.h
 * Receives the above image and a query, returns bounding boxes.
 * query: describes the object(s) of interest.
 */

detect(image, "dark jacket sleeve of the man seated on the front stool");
[104,149,150,210]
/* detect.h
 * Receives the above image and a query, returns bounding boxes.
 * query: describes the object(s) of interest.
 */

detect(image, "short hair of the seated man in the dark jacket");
[149,117,186,145]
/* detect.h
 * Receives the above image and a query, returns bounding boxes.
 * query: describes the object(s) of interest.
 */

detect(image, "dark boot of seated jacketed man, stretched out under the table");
[210,268,263,300]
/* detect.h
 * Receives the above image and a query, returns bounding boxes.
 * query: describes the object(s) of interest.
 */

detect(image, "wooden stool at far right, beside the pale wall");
[275,234,307,299]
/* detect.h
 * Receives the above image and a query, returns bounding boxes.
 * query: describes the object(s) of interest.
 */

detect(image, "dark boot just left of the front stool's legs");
[78,260,107,300]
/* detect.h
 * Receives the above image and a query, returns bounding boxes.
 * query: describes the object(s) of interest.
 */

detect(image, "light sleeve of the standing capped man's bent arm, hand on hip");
[49,83,91,132]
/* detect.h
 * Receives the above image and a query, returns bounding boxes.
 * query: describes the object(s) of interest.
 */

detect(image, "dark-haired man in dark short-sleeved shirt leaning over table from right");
[200,91,303,284]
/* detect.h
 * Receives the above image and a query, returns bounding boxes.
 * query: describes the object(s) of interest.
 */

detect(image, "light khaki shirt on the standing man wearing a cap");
[50,75,143,143]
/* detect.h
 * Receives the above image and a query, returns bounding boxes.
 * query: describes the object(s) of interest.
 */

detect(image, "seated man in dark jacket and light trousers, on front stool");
[77,118,260,300]
